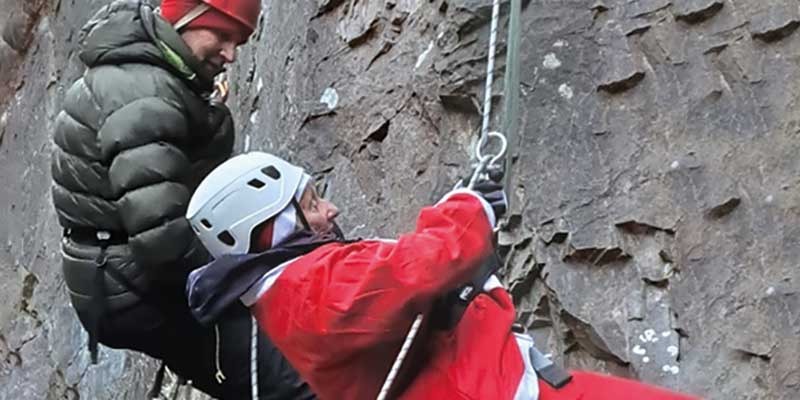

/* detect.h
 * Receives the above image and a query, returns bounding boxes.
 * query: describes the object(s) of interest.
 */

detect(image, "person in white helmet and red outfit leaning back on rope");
[187,152,690,400]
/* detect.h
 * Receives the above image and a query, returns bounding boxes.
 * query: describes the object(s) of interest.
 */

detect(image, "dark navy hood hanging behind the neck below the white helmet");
[186,230,344,325]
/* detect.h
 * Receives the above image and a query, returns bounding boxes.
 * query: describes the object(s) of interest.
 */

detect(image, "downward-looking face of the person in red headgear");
[181,28,239,75]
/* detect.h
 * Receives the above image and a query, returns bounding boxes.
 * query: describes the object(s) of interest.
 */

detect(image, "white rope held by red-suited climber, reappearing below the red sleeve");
[376,0,505,400]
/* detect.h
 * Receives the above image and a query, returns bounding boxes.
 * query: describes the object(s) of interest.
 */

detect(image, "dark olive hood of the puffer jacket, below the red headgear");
[80,0,214,92]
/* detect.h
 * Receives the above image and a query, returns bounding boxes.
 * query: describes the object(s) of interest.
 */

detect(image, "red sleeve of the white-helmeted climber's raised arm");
[254,191,494,374]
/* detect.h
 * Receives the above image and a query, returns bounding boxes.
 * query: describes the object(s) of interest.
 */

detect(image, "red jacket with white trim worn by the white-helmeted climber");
[243,191,536,400]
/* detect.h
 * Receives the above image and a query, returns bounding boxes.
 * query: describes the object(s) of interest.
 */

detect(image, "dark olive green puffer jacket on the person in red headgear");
[52,0,234,312]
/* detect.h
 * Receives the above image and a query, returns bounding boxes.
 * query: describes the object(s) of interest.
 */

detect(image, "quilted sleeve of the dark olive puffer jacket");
[99,97,205,267]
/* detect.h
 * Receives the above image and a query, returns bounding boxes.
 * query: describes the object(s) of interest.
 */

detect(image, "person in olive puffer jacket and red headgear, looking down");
[52,0,315,400]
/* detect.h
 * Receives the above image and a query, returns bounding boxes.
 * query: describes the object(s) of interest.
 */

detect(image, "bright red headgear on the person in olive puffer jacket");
[161,0,253,43]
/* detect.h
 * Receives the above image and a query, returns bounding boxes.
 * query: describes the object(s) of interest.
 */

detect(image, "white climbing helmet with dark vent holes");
[186,152,310,258]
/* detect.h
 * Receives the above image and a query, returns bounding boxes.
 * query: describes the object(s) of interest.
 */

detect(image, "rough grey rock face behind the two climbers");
[0,0,800,400]
